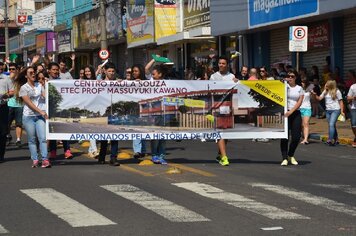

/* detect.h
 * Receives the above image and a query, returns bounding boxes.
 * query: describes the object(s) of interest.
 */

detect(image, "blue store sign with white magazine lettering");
[247,0,319,28]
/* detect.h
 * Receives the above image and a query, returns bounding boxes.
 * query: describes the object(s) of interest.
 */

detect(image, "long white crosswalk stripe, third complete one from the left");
[173,182,310,220]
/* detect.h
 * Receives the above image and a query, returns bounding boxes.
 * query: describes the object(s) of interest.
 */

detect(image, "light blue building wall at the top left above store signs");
[56,0,93,29]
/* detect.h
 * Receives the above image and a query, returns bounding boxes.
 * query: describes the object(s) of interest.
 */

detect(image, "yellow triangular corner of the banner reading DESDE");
[240,80,286,107]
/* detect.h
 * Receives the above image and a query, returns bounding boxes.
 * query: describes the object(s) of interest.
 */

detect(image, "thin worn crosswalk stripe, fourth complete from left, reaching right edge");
[251,183,356,216]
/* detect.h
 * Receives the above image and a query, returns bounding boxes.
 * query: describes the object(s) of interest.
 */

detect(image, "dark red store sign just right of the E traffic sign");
[308,22,330,48]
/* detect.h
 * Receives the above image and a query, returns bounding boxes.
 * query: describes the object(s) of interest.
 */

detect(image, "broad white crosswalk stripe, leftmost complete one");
[21,188,116,227]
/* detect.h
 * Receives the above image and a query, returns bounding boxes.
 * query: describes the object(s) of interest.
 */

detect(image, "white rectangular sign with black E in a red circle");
[289,26,308,52]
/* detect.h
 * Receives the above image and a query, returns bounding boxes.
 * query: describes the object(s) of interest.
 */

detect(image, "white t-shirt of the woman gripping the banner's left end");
[19,83,46,116]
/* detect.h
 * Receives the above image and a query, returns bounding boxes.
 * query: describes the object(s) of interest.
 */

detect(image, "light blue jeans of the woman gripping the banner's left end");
[22,116,47,161]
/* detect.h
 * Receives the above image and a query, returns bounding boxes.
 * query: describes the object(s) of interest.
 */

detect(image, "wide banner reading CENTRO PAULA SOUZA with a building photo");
[46,80,287,140]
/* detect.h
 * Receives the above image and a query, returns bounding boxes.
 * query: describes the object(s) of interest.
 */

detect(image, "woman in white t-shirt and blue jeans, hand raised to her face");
[314,80,345,146]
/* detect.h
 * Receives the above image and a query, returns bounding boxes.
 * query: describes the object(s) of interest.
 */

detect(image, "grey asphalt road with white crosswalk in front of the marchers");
[0,137,356,235]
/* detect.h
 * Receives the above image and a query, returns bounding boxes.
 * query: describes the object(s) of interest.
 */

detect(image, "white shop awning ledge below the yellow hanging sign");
[157,27,214,45]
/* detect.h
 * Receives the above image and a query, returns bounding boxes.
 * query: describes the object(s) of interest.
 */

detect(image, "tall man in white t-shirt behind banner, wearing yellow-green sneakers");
[210,56,238,166]
